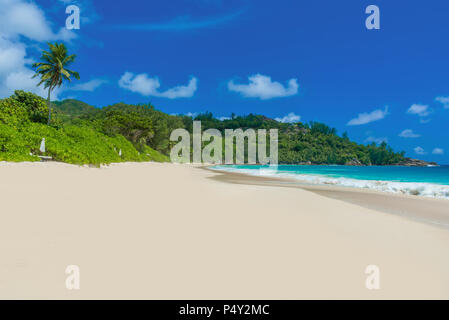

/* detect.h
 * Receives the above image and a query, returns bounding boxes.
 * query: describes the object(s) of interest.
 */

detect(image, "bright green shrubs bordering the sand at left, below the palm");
[0,91,168,165]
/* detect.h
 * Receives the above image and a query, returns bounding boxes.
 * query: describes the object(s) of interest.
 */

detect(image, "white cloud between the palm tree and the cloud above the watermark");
[119,72,198,99]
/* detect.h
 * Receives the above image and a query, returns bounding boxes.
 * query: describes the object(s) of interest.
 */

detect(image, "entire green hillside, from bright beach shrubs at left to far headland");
[0,91,405,165]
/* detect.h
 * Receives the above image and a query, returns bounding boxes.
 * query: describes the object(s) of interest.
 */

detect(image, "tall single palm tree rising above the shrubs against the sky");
[33,43,80,125]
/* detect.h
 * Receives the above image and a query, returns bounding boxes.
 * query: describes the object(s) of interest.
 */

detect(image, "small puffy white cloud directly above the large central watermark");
[228,74,299,100]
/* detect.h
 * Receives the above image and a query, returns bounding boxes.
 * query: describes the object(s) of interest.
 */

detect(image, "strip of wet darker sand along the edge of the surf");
[204,166,449,230]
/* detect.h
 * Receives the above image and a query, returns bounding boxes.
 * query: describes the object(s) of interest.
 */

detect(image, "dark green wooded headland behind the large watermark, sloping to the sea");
[187,113,405,165]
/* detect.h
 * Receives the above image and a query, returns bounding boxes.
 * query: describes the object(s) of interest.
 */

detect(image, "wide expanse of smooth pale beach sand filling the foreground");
[0,163,449,299]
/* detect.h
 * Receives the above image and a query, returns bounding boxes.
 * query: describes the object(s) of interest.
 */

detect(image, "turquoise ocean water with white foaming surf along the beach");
[212,165,449,200]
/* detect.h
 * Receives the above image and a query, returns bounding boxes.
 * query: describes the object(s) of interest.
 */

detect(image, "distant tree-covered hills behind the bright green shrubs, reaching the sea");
[50,100,405,165]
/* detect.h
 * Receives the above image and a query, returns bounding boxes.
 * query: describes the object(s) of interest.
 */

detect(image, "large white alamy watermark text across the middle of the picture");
[170,121,278,165]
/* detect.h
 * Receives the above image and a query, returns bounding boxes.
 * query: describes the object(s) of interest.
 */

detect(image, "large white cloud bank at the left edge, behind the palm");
[0,0,75,99]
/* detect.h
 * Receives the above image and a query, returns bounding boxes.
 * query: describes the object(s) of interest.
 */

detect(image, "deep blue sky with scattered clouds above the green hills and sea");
[0,0,449,164]
